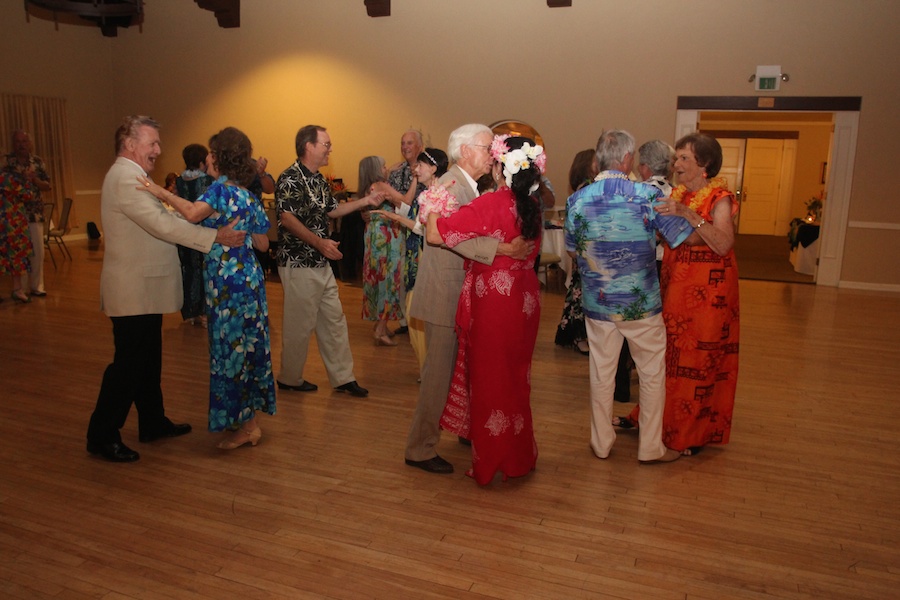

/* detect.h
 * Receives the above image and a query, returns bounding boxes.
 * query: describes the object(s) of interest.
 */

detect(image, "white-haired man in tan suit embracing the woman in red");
[406,124,529,473]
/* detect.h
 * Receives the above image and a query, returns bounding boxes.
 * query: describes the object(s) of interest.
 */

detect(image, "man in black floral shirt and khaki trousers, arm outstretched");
[275,125,383,397]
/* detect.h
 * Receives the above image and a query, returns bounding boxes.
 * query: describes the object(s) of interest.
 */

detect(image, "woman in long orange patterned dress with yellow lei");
[613,133,740,455]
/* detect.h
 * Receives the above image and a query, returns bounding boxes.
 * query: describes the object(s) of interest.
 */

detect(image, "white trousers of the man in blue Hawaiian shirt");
[584,315,666,460]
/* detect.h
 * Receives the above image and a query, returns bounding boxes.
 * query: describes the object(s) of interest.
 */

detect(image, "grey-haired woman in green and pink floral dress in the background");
[358,156,404,346]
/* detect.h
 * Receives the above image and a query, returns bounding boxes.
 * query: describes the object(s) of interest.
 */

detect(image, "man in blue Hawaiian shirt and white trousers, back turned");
[566,130,692,463]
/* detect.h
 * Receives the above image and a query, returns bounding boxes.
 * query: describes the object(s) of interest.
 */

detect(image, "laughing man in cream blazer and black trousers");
[87,116,246,462]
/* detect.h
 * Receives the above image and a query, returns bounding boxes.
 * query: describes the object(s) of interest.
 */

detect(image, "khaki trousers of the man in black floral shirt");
[277,266,356,387]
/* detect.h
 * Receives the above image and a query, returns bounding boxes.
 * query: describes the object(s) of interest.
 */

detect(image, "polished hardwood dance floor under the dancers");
[0,242,900,600]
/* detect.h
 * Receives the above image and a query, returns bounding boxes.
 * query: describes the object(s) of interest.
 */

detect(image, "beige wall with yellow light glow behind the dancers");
[0,0,900,289]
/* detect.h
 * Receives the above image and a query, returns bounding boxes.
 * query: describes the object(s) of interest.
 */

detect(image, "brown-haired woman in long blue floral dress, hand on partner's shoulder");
[140,127,275,450]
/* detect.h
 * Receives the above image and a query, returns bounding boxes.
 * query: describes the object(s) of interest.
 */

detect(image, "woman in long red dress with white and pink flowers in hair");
[426,136,546,485]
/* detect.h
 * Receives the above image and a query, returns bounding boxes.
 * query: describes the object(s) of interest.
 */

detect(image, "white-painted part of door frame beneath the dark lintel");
[675,108,859,287]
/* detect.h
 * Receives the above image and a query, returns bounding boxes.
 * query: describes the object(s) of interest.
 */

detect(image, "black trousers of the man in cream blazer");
[87,315,172,444]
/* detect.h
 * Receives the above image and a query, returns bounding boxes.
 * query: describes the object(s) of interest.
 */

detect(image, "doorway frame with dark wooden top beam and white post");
[675,96,862,286]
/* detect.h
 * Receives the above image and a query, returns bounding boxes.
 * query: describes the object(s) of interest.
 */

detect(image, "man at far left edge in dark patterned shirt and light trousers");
[6,129,50,297]
